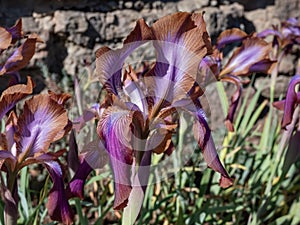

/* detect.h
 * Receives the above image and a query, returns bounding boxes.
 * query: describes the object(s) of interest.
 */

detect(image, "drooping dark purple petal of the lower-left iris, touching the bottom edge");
[44,161,74,224]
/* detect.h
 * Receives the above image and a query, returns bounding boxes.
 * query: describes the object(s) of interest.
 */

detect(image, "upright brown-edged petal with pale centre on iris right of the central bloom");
[220,37,272,77]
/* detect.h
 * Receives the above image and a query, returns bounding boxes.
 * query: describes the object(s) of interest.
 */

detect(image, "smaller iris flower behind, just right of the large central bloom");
[201,28,277,131]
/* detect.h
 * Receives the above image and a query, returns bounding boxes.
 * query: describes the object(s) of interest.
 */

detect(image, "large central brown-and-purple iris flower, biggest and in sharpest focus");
[96,12,232,212]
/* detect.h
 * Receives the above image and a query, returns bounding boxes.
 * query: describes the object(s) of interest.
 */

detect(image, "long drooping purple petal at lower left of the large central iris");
[97,106,134,209]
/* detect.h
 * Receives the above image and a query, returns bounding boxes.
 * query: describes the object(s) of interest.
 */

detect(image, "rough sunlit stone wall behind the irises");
[0,0,300,79]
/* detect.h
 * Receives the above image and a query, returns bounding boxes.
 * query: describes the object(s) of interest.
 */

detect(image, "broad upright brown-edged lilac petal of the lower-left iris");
[15,94,68,161]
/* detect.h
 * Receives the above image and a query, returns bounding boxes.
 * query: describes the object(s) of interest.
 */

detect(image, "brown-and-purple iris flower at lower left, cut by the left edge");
[0,78,72,224]
